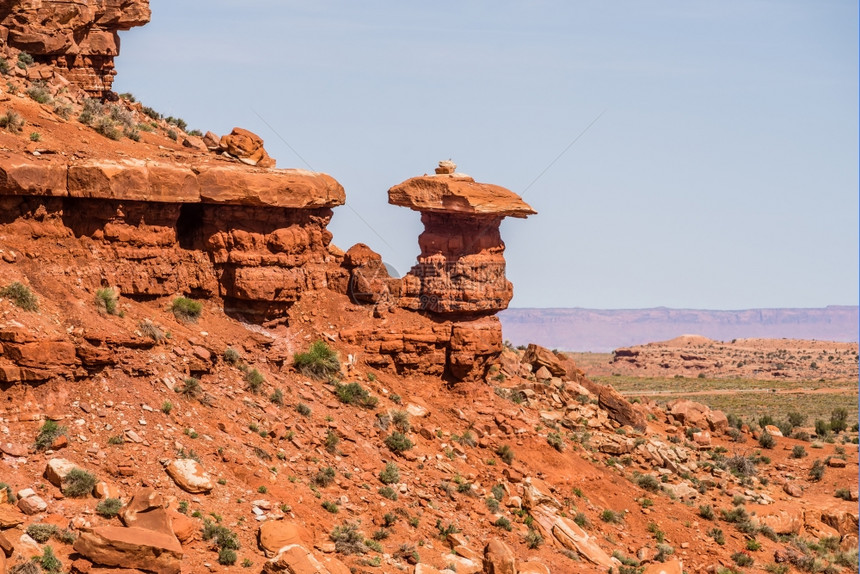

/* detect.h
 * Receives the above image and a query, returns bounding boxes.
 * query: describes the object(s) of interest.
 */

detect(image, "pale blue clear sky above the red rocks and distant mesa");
[115,0,860,309]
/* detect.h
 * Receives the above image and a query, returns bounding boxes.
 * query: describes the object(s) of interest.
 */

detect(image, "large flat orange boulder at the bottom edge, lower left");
[74,526,182,574]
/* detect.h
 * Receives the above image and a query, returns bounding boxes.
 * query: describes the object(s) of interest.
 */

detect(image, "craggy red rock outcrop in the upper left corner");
[0,0,150,96]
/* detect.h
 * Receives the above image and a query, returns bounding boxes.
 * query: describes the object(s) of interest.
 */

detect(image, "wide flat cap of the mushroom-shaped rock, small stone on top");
[388,160,537,219]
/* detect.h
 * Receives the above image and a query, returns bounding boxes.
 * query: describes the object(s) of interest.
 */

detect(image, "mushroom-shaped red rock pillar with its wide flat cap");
[388,162,536,314]
